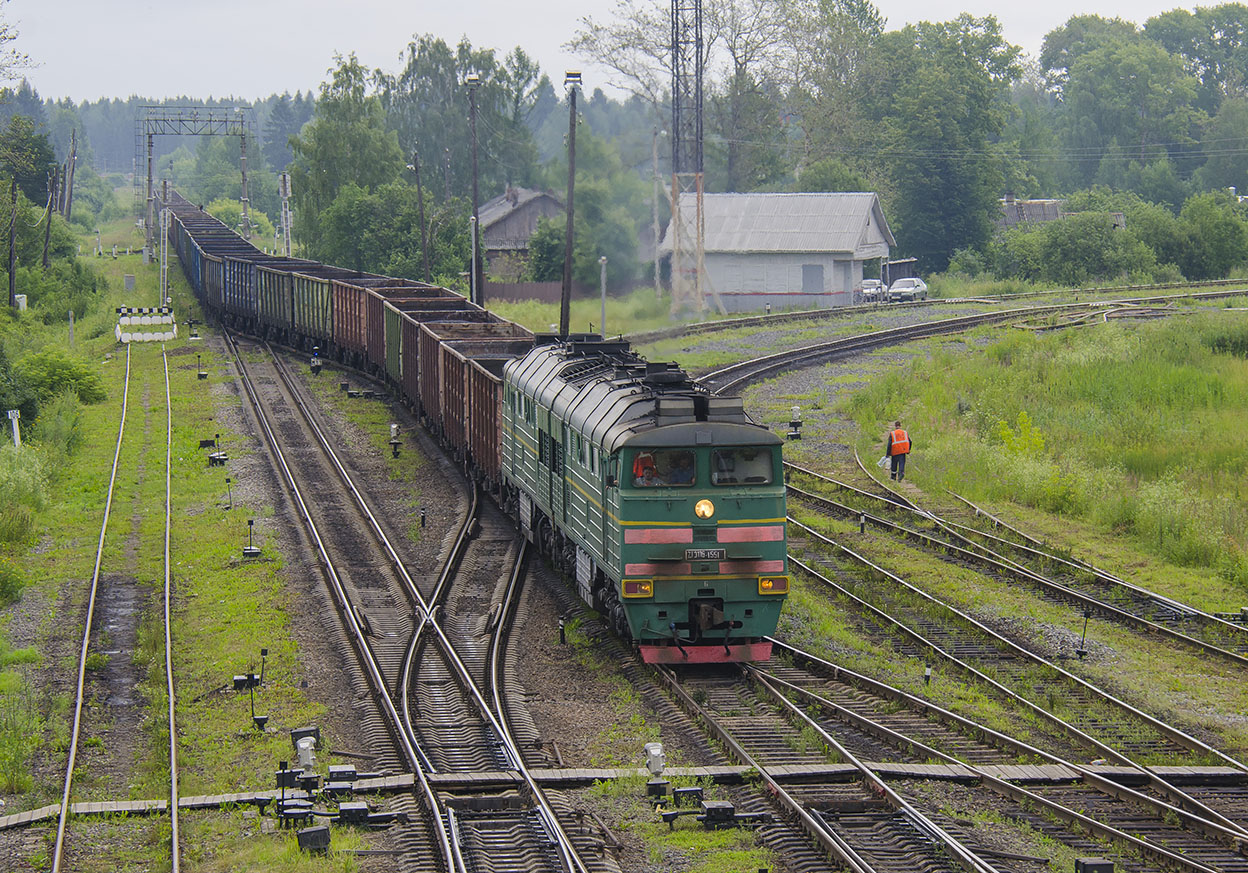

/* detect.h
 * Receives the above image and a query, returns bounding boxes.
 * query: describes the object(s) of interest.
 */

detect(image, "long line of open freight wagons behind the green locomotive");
[165,193,543,490]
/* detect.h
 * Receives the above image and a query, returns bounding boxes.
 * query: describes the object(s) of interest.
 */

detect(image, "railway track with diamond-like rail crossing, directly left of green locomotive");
[236,331,599,873]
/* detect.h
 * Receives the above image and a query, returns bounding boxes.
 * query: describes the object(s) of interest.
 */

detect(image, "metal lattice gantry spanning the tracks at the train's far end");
[135,106,255,257]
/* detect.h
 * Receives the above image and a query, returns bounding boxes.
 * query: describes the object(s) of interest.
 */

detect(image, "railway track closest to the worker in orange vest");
[785,464,1248,667]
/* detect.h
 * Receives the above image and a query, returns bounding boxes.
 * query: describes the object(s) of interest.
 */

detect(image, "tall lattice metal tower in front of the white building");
[670,0,724,313]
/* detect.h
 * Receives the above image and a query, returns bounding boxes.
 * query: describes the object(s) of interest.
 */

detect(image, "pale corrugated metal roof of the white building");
[659,192,897,253]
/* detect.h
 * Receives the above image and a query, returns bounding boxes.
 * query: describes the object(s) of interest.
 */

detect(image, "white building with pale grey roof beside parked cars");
[659,192,897,312]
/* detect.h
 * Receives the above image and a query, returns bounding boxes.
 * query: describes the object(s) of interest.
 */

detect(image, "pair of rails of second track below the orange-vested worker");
[789,536,1248,837]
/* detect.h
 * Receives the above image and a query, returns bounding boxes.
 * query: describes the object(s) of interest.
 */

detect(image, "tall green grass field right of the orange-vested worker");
[842,312,1248,587]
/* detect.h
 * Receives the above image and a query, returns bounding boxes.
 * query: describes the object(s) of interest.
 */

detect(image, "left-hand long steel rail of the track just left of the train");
[223,330,454,871]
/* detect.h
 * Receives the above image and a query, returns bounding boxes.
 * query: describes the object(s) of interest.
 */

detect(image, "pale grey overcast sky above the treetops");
[7,0,1198,101]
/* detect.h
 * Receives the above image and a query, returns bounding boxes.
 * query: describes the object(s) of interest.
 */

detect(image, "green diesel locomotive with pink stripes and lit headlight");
[500,335,789,663]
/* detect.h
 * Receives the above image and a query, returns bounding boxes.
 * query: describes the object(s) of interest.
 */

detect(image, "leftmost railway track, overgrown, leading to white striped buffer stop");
[51,345,181,873]
